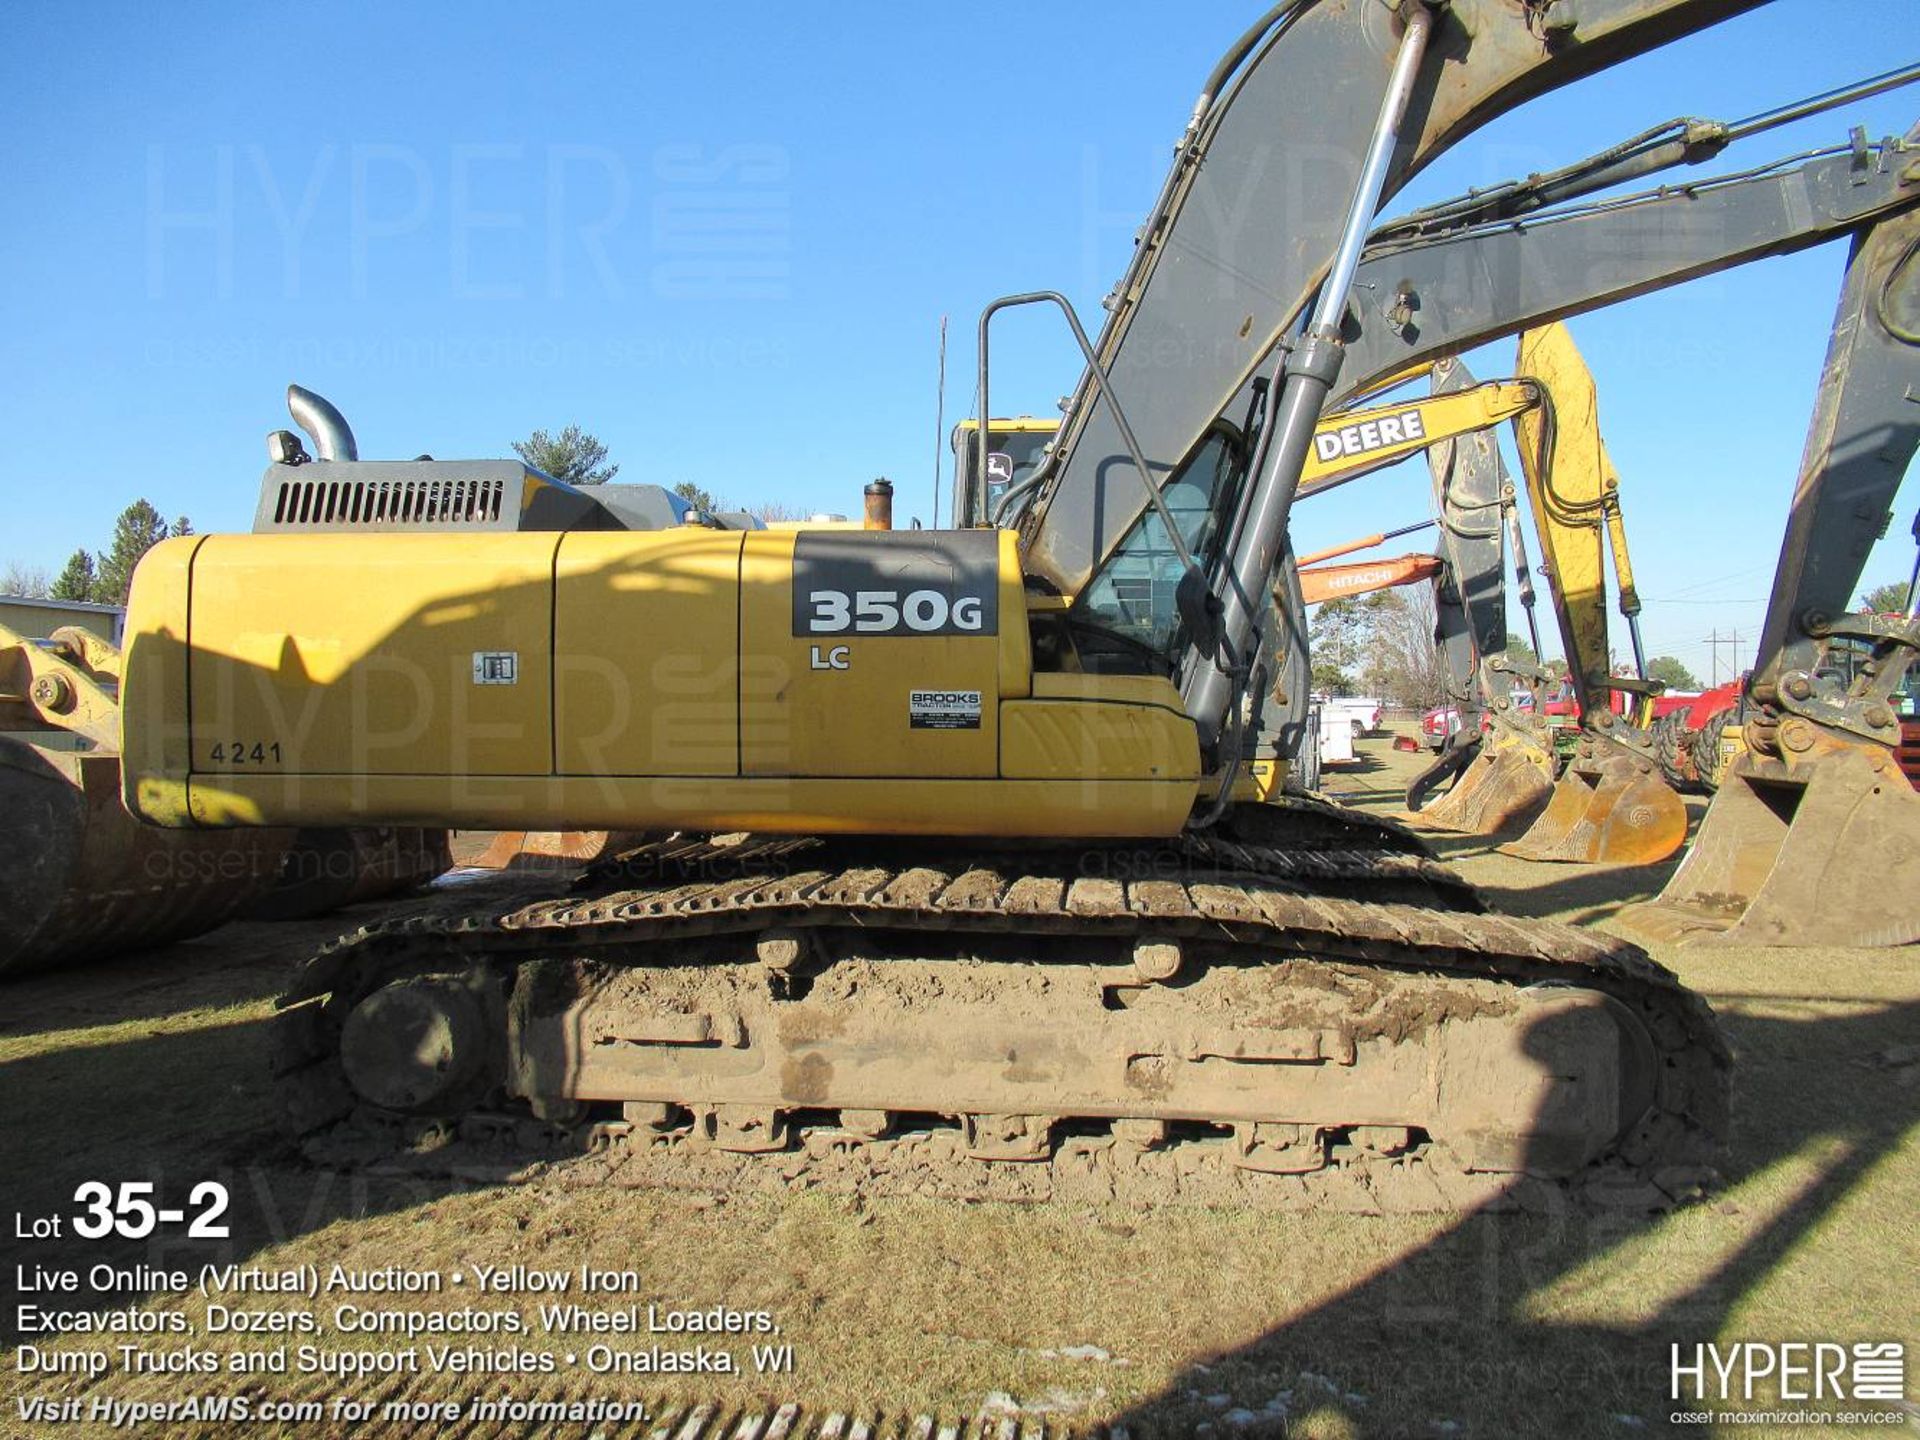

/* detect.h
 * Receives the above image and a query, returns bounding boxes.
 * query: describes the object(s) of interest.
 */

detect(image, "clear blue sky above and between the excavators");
[0,0,1920,687]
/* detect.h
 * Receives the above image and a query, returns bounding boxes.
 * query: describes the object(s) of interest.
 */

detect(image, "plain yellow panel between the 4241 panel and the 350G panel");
[553,528,741,776]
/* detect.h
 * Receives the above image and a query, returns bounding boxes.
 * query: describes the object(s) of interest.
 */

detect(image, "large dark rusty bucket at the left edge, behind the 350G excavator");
[0,737,292,975]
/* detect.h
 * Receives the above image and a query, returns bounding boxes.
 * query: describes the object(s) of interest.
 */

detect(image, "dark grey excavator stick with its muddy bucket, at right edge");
[1622,209,1920,945]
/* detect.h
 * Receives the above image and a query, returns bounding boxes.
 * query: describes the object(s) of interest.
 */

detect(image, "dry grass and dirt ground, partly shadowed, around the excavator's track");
[0,739,1920,1438]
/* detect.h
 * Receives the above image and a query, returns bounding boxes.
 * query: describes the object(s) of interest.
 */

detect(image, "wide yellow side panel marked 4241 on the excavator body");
[192,534,561,776]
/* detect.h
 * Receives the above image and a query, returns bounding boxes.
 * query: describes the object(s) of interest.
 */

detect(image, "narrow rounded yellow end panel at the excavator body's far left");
[121,536,204,826]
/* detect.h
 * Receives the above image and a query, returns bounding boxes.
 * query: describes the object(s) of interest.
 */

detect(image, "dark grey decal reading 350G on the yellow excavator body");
[793,530,1000,636]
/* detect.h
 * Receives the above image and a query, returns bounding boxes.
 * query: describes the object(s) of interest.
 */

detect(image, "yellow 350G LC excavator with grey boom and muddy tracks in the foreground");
[121,0,1920,1210]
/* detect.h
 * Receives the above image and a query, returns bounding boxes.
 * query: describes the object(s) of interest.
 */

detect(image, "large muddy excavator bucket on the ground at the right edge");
[1620,745,1920,947]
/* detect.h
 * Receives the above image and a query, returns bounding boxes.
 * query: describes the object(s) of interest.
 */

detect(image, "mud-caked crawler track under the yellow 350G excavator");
[275,814,1728,1212]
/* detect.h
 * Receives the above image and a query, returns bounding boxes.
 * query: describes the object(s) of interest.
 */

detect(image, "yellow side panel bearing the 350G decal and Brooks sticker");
[739,530,1027,780]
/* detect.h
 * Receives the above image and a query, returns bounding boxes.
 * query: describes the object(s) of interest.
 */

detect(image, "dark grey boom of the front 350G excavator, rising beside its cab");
[1021,0,1763,603]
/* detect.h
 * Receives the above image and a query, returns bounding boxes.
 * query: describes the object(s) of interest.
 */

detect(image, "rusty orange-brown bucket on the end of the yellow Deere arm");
[1500,755,1686,866]
